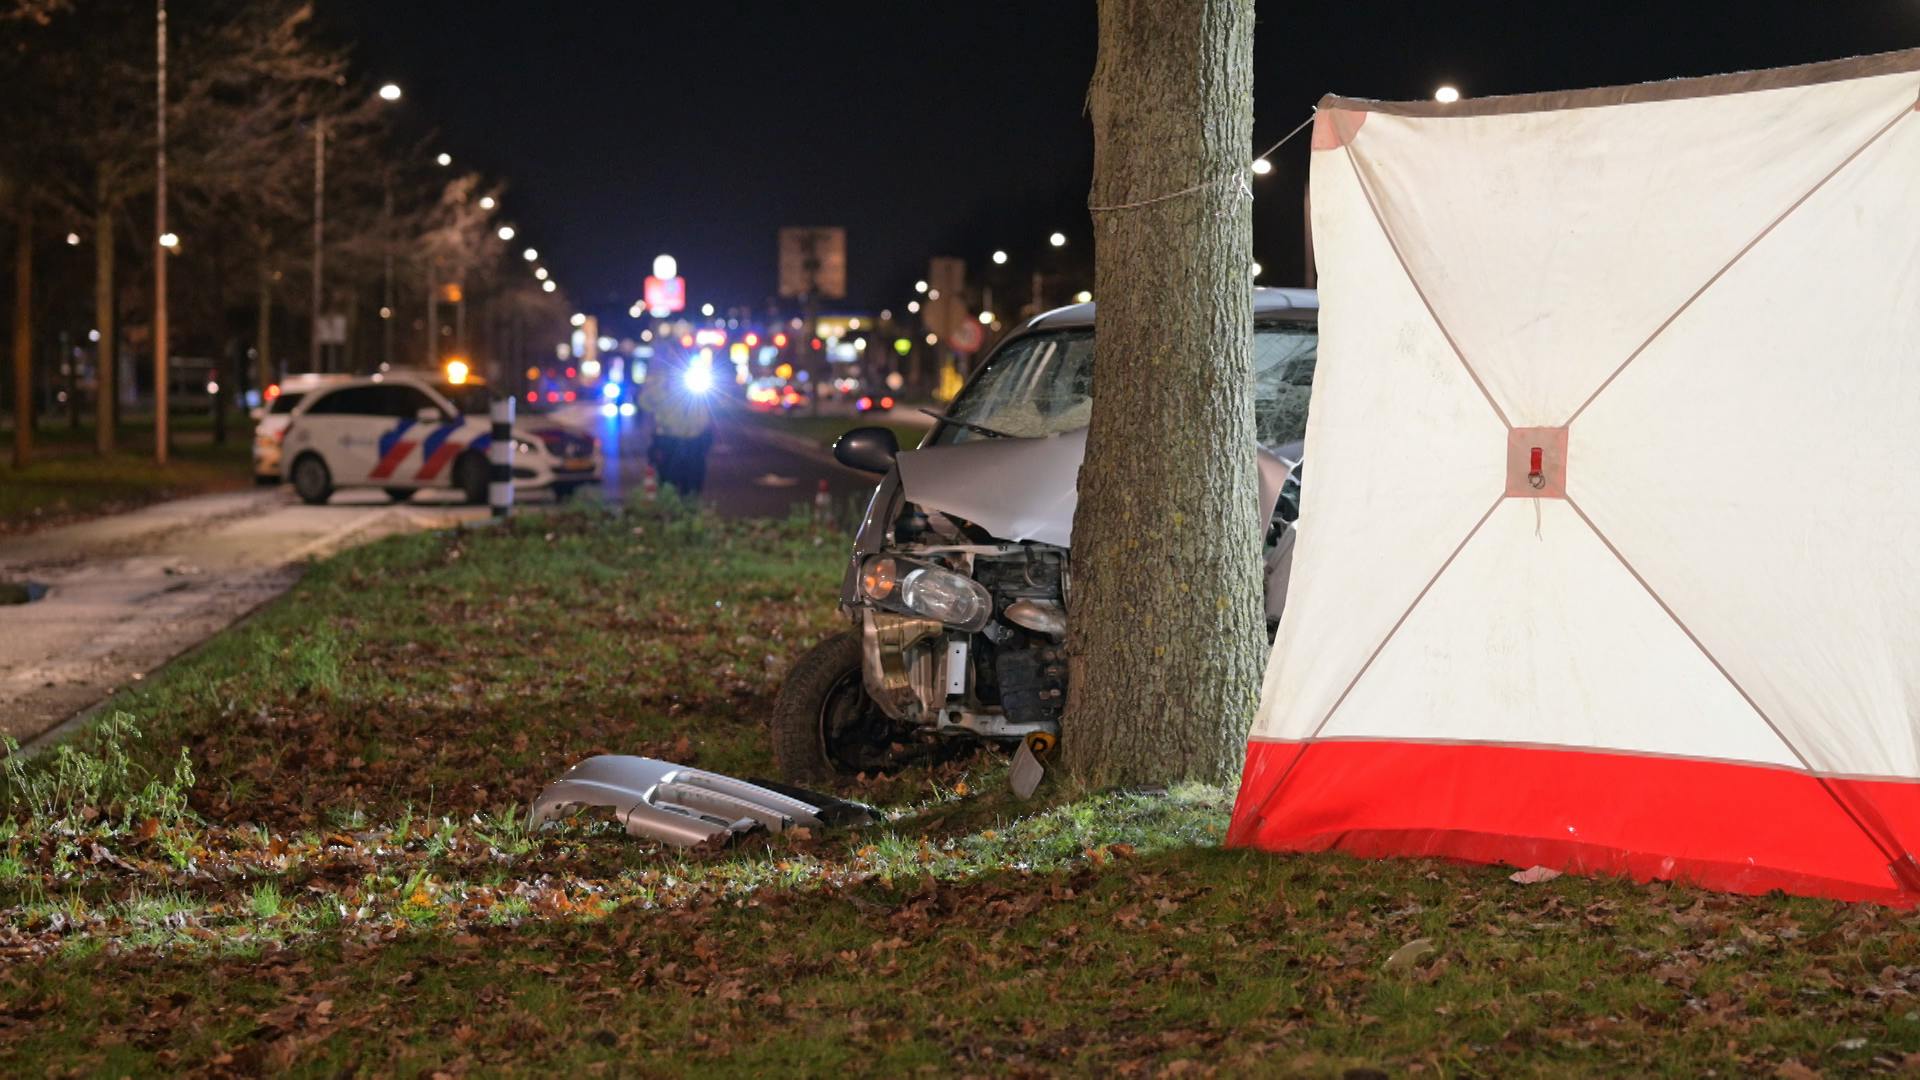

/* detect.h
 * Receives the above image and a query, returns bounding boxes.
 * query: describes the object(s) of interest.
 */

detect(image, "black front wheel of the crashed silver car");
[774,632,918,784]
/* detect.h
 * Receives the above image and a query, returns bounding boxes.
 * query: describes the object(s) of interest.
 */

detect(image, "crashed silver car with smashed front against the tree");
[774,288,1319,782]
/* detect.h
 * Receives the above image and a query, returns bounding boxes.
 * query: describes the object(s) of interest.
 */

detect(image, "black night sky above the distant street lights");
[319,0,1920,313]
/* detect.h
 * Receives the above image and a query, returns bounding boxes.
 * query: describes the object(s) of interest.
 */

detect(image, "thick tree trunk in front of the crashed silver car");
[1064,0,1265,786]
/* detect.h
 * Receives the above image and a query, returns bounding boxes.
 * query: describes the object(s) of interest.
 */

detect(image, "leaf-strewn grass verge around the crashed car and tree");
[0,503,1920,1076]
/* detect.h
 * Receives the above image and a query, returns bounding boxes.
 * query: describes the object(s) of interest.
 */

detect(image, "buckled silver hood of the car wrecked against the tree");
[897,429,1294,548]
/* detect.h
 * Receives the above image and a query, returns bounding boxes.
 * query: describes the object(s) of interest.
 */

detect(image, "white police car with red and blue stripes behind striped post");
[280,373,605,505]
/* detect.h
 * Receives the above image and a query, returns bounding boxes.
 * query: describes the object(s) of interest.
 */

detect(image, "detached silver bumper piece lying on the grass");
[532,753,874,847]
